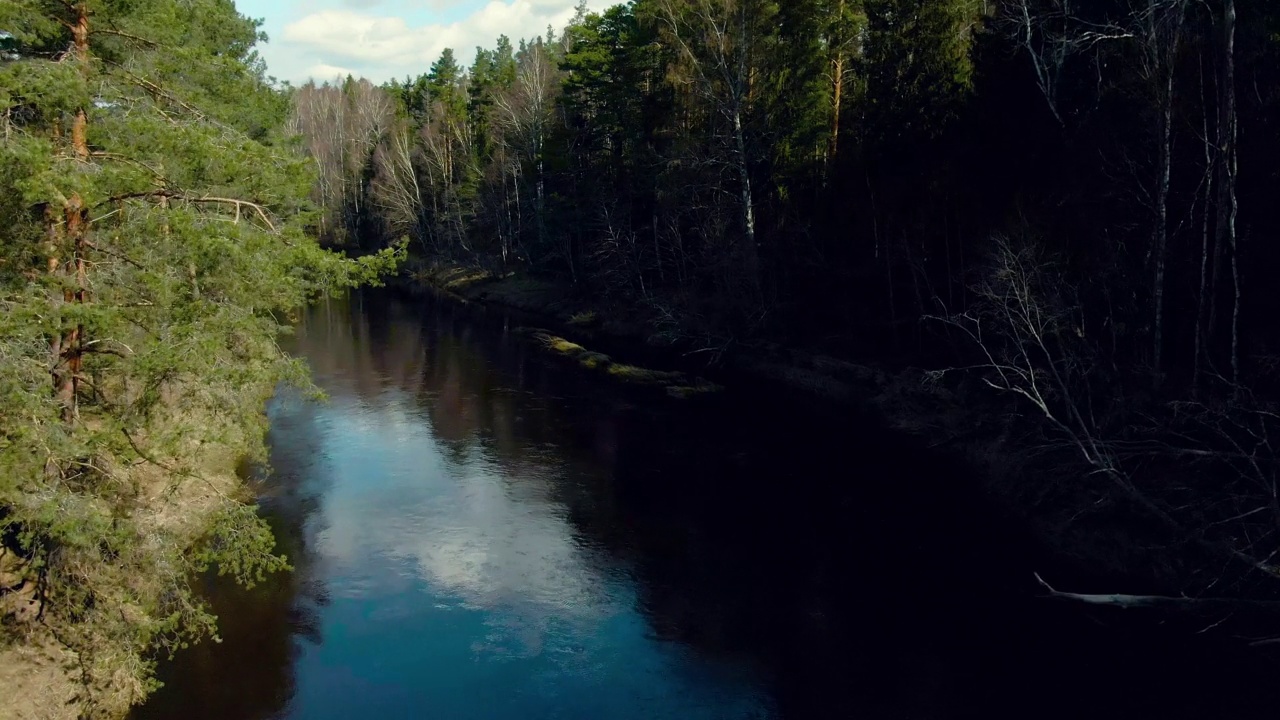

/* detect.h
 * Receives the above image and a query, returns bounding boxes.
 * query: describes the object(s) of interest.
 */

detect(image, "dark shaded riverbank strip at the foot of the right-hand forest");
[412,260,1269,596]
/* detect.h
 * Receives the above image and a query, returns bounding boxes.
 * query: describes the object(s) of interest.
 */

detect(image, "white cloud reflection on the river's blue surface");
[308,393,619,638]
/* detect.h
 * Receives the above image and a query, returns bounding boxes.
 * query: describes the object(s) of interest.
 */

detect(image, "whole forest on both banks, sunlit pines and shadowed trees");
[0,0,1280,716]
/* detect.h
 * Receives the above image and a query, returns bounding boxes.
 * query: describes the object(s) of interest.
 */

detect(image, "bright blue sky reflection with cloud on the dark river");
[262,338,773,720]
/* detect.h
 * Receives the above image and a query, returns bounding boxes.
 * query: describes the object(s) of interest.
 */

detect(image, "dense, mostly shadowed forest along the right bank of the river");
[291,0,1280,596]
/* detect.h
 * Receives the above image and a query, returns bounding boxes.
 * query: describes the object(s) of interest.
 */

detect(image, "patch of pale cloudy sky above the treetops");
[236,0,620,83]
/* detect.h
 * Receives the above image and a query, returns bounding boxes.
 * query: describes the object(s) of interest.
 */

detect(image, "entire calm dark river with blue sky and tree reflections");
[136,286,1280,720]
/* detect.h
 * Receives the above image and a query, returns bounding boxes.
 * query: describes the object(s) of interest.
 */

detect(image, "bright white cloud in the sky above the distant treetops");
[262,0,616,82]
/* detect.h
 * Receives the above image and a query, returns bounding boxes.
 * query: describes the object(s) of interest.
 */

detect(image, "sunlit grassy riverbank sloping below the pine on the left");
[0,404,280,720]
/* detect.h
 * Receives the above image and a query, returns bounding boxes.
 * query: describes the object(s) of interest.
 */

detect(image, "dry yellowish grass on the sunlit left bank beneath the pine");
[0,399,261,720]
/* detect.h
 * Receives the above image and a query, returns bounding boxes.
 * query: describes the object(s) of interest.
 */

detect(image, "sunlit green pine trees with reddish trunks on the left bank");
[0,0,392,716]
